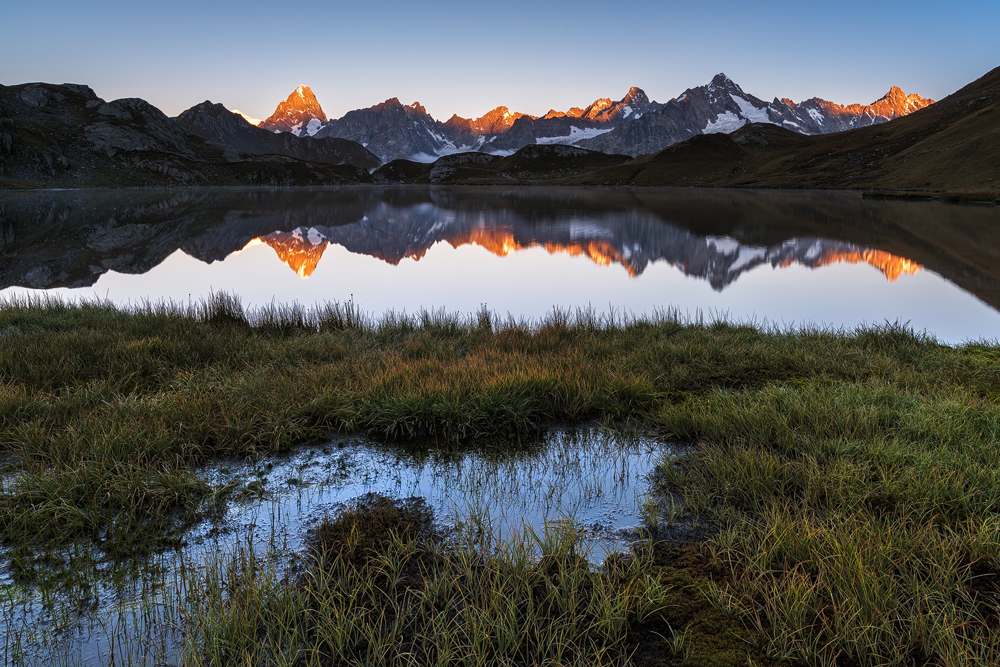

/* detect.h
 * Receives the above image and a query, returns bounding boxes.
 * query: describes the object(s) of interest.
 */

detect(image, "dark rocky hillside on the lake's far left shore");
[0,83,370,189]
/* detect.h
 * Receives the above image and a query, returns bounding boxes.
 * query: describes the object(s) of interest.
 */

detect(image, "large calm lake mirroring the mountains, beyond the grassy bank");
[0,187,1000,343]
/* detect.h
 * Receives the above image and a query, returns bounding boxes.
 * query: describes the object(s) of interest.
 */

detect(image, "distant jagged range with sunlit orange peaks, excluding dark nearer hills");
[242,74,933,162]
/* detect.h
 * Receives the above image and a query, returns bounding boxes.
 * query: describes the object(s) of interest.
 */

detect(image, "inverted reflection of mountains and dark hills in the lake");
[0,187,1000,308]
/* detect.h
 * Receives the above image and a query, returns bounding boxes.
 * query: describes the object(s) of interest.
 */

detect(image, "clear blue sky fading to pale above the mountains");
[0,0,1000,120]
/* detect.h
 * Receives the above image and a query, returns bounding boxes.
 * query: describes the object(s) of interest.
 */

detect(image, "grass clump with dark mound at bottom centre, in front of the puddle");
[185,496,688,666]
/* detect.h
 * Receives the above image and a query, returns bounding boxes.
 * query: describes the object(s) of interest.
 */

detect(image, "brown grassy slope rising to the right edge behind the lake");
[564,67,1000,199]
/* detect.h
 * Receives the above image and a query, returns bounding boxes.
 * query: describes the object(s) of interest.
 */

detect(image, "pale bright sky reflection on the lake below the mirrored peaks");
[15,237,1000,343]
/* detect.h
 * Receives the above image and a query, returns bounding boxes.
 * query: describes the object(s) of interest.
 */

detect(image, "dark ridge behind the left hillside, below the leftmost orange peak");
[174,100,382,171]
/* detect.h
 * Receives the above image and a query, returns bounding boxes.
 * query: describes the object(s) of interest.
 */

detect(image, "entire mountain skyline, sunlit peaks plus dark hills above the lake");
[0,68,1000,200]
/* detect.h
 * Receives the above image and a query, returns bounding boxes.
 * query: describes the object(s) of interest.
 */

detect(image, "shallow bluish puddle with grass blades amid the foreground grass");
[0,428,667,665]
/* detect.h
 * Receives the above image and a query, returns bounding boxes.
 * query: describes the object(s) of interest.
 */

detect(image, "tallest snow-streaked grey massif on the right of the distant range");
[579,74,933,157]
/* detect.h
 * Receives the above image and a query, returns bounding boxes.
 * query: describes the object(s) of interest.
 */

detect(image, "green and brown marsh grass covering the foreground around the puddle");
[0,295,1000,667]
